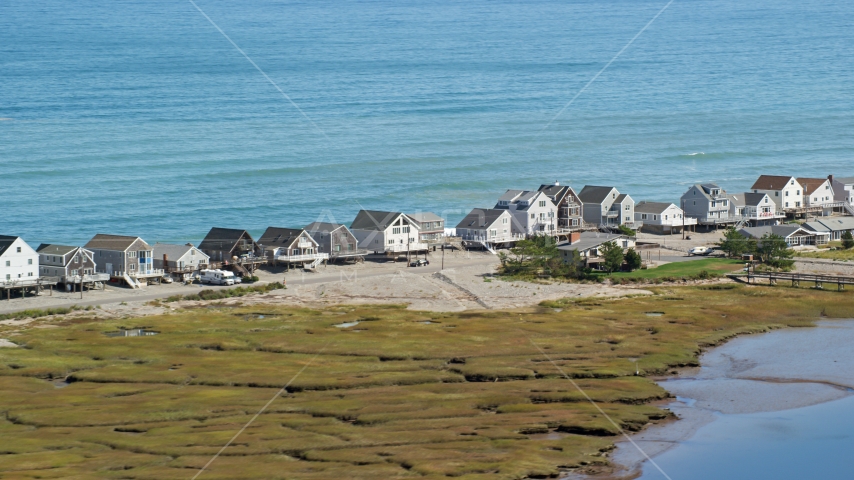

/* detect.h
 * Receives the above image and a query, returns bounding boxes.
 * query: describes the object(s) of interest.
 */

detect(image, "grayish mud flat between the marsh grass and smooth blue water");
[563,319,854,480]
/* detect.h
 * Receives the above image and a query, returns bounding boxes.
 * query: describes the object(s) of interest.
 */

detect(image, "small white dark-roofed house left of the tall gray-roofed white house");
[456,208,525,250]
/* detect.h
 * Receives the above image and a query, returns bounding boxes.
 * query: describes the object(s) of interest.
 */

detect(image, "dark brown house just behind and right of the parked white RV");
[199,227,267,275]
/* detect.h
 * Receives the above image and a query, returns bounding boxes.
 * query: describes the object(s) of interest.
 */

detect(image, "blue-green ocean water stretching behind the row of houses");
[0,0,854,244]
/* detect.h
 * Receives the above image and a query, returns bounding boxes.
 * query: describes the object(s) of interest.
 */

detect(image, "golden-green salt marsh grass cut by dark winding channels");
[0,286,854,480]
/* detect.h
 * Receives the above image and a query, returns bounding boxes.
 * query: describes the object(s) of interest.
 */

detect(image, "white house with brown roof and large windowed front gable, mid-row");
[350,210,428,254]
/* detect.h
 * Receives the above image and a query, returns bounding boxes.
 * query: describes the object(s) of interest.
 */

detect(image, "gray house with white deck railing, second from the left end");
[36,243,110,285]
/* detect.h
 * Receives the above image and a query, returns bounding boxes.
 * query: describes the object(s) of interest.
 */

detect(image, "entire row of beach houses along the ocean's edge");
[0,175,854,289]
